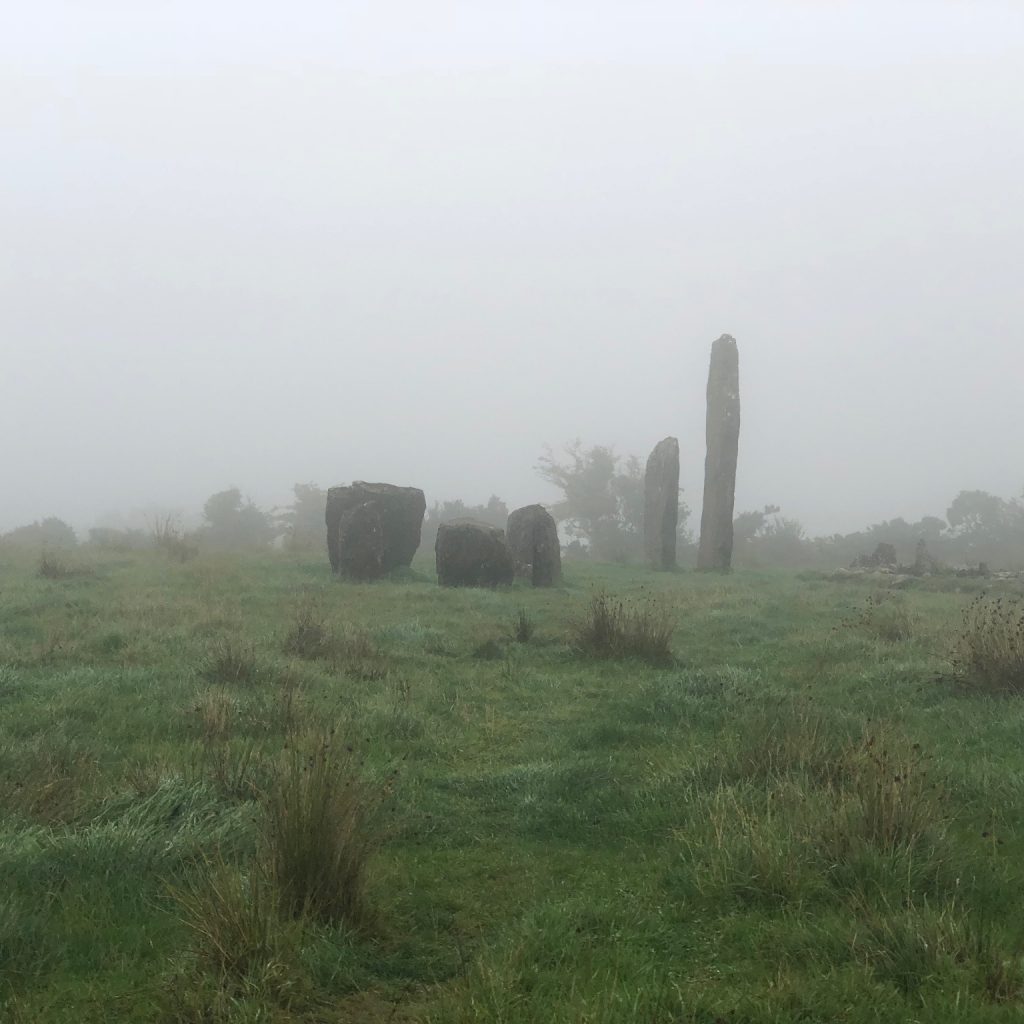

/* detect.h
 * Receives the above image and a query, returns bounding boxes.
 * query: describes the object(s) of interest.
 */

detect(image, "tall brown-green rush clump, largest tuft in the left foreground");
[263,734,386,927]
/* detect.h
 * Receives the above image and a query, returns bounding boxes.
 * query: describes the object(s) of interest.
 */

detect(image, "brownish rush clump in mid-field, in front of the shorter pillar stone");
[572,591,674,665]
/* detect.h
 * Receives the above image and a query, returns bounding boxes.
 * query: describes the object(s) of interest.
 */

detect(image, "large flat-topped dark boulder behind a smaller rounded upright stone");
[325,480,427,579]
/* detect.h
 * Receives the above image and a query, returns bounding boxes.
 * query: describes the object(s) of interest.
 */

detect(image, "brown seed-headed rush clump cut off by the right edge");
[953,594,1024,693]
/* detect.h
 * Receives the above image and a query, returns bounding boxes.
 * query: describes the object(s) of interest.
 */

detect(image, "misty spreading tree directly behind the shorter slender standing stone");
[536,440,690,562]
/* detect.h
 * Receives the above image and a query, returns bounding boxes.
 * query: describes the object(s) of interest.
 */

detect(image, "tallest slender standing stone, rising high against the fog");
[697,334,739,570]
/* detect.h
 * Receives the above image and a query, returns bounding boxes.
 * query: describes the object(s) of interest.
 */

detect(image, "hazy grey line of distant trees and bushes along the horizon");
[8,460,1024,569]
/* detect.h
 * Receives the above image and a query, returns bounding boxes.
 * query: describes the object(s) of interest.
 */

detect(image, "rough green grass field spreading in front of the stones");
[0,551,1024,1024]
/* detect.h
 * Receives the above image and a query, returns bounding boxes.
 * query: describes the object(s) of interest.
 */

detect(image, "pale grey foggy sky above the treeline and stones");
[0,0,1024,534]
